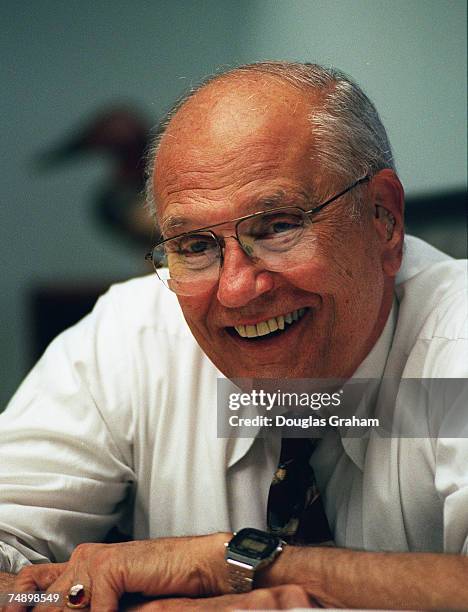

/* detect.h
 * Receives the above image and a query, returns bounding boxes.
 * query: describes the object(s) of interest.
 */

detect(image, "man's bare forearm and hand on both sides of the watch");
[7,533,468,610]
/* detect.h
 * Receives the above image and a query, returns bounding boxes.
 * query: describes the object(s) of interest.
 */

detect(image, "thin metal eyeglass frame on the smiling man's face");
[145,174,371,274]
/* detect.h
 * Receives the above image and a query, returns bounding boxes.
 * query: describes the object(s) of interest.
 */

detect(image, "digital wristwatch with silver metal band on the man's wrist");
[224,527,286,593]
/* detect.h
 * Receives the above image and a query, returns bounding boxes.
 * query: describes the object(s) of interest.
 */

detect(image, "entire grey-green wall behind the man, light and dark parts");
[0,0,466,406]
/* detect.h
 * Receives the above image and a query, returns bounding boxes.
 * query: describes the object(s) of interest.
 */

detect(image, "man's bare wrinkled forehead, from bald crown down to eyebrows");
[154,78,322,230]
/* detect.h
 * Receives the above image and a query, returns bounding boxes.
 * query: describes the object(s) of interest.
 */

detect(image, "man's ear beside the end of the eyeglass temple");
[369,168,405,277]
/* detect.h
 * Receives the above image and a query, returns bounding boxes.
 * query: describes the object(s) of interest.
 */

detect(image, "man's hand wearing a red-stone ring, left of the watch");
[7,534,231,612]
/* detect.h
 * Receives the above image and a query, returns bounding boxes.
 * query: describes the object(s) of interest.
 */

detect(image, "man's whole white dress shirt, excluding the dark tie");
[0,238,468,571]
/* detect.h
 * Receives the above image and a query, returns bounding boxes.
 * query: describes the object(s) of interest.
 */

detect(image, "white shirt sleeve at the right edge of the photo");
[423,286,468,554]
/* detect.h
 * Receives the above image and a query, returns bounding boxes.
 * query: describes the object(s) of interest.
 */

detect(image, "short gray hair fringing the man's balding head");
[146,61,395,218]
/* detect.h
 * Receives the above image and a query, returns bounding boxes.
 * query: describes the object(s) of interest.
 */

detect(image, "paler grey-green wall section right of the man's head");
[241,0,467,193]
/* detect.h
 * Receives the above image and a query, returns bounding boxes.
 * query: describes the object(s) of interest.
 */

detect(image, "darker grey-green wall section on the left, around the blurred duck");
[0,0,245,410]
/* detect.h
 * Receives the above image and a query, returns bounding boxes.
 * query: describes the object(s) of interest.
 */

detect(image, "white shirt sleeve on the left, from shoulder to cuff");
[0,293,135,567]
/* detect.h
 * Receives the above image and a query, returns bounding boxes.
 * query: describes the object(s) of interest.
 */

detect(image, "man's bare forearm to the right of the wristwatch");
[258,546,468,609]
